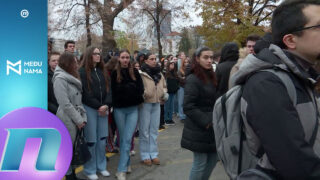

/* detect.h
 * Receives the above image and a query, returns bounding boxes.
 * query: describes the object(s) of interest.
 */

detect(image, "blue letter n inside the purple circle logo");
[0,129,61,171]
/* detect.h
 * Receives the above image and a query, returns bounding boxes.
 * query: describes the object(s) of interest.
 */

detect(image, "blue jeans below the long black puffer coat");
[189,152,218,180]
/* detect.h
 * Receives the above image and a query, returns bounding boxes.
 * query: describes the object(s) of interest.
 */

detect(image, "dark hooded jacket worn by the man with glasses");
[236,48,320,180]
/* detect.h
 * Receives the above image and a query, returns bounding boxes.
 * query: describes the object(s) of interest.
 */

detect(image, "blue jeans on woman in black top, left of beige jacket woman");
[114,106,138,172]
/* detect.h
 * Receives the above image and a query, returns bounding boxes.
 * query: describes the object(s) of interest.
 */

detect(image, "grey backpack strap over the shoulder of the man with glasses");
[261,69,297,107]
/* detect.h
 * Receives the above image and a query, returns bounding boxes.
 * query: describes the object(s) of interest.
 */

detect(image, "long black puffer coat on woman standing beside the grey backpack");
[181,74,216,153]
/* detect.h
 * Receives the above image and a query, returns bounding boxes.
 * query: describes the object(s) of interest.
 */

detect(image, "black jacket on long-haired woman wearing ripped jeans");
[79,67,112,110]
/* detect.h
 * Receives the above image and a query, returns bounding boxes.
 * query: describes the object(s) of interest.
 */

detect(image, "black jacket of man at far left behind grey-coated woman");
[48,68,59,114]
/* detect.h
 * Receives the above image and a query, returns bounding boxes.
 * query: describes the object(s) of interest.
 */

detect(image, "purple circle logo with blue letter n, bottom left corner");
[0,108,72,180]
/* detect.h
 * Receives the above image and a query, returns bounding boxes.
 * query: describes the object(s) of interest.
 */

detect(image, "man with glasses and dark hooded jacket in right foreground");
[214,0,320,180]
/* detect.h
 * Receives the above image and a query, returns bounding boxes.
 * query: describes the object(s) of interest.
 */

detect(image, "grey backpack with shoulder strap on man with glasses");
[213,69,297,180]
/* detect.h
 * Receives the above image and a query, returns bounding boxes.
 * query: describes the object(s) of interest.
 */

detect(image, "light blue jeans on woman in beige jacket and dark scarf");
[139,103,160,160]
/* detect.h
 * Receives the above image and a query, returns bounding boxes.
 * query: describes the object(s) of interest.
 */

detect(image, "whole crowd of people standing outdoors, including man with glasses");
[48,0,320,180]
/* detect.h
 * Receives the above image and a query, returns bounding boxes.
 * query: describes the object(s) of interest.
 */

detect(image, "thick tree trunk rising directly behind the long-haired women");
[102,17,117,58]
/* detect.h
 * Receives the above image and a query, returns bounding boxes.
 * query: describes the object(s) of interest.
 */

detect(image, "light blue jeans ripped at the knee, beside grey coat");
[84,105,108,175]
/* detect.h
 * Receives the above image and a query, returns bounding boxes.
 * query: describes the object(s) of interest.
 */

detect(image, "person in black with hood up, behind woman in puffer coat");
[216,42,239,98]
